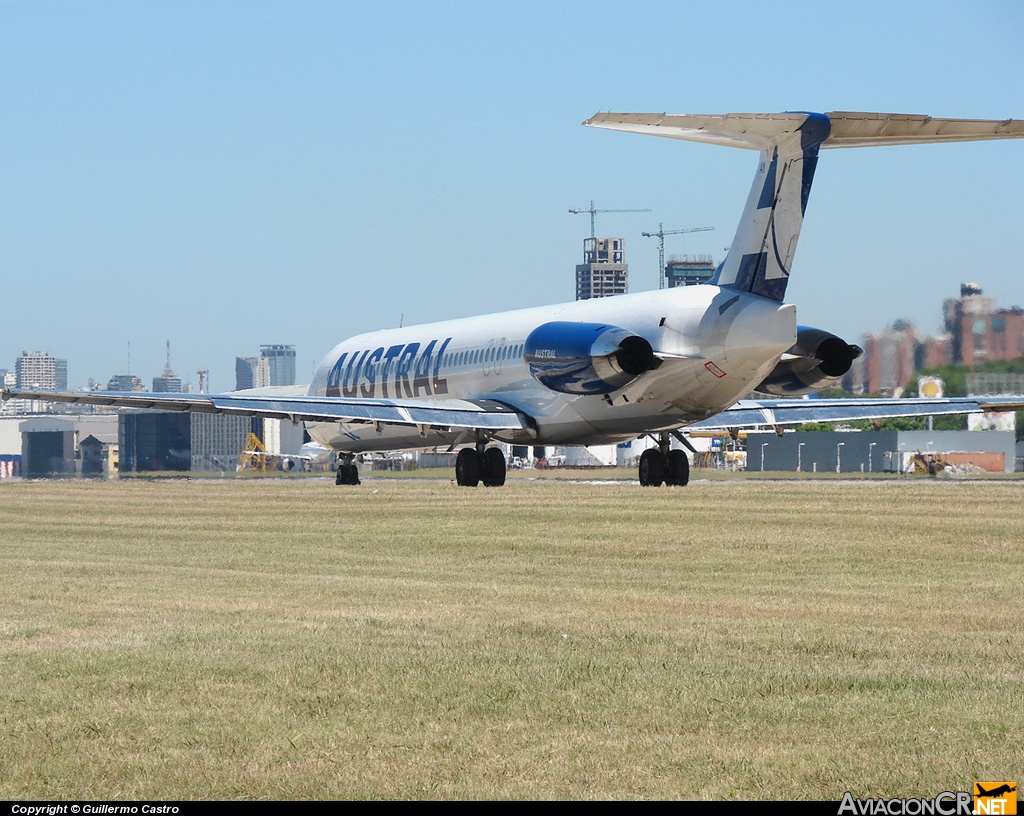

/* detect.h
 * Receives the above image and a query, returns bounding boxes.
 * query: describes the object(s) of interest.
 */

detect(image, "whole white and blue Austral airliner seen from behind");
[3,113,1024,486]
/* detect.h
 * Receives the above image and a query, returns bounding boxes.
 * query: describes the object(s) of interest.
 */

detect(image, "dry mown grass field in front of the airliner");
[0,479,1024,800]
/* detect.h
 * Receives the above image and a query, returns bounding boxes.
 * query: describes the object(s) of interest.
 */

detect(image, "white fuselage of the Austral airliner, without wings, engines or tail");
[299,286,797,453]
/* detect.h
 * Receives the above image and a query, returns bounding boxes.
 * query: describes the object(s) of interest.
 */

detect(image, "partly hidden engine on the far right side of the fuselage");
[756,326,864,396]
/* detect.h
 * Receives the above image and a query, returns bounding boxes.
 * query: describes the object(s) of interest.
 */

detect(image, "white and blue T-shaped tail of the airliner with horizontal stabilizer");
[584,113,1024,301]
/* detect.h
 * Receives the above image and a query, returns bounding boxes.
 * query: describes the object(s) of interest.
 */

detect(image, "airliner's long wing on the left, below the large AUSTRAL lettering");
[3,389,532,431]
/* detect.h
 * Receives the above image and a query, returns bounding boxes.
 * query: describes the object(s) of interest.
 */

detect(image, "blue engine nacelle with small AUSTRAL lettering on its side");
[523,321,660,394]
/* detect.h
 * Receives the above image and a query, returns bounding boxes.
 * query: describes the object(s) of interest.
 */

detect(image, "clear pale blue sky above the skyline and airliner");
[0,0,1024,390]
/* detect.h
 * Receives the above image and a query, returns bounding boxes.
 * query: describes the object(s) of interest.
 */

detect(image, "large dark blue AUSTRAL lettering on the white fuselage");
[327,337,452,399]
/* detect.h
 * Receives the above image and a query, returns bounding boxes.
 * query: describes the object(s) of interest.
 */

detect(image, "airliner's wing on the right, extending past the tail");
[689,396,1024,430]
